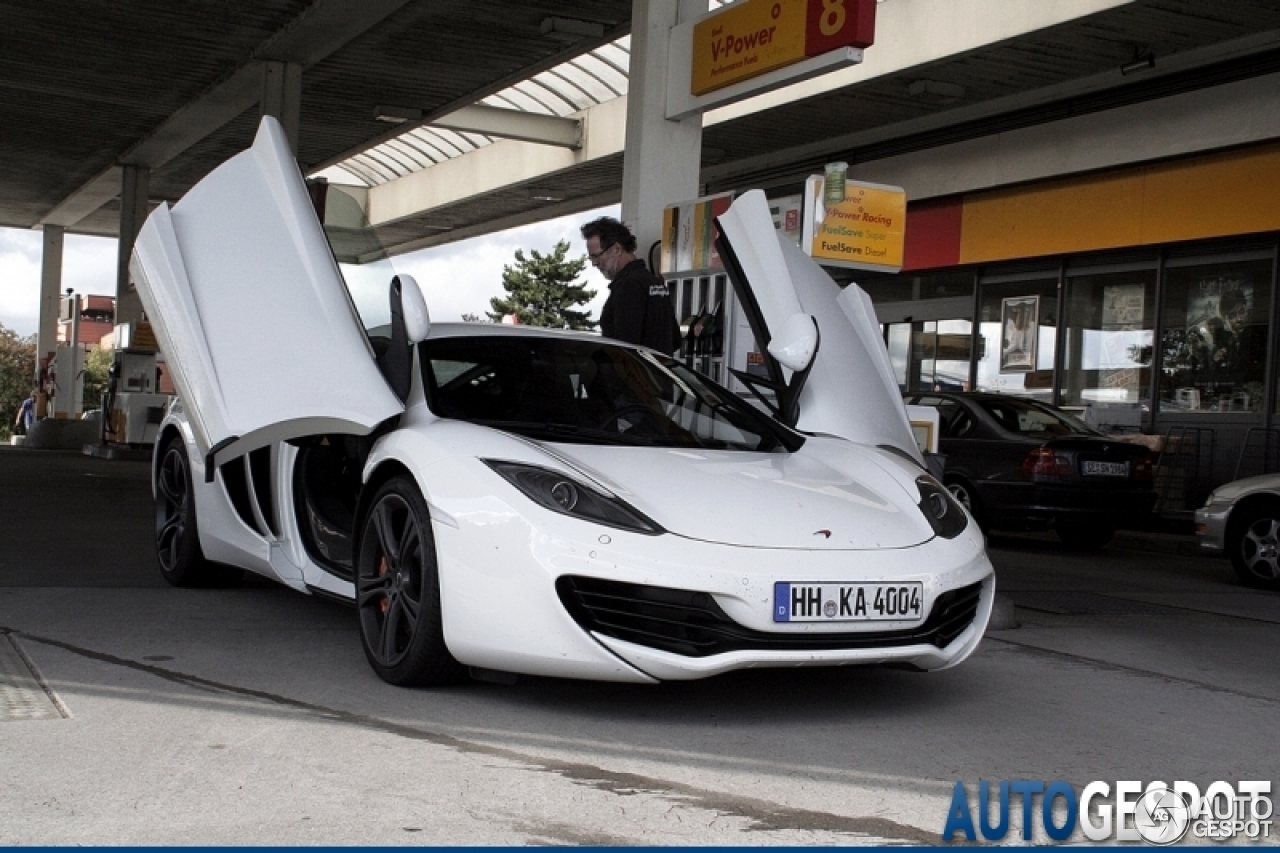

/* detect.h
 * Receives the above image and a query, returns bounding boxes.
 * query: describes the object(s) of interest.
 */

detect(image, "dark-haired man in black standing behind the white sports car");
[582,216,680,355]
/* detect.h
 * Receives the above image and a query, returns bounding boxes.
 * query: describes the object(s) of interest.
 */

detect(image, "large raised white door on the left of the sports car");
[131,117,403,478]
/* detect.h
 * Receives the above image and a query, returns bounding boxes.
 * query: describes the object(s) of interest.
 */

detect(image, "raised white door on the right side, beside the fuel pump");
[716,190,923,465]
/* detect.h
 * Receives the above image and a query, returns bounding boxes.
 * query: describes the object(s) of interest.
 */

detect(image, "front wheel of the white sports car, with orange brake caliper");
[356,475,466,686]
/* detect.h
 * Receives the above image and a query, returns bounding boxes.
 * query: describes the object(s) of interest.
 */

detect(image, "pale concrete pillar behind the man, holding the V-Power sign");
[622,0,707,260]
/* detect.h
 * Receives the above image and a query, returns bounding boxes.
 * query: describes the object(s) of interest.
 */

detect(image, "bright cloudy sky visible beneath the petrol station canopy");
[0,205,618,336]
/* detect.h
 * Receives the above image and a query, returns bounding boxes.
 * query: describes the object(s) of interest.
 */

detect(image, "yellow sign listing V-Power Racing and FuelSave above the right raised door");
[803,175,906,273]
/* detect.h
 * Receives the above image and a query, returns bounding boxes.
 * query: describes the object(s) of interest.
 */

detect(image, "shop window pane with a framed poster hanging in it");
[978,278,1057,401]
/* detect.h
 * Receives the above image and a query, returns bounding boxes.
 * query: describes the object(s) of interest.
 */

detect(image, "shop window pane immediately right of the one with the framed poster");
[1062,269,1156,406]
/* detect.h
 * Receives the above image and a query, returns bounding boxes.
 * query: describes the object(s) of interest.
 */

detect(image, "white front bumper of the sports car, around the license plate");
[435,491,995,681]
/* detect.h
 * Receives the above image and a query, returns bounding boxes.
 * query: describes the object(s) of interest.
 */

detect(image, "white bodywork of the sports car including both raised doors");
[145,119,995,683]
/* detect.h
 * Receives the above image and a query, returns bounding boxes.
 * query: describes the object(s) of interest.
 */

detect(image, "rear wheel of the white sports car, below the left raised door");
[156,435,243,587]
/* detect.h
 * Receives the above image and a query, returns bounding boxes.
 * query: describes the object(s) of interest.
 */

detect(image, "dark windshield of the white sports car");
[421,336,804,451]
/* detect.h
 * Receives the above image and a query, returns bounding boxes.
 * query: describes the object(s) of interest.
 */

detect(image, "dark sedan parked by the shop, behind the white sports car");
[905,392,1156,548]
